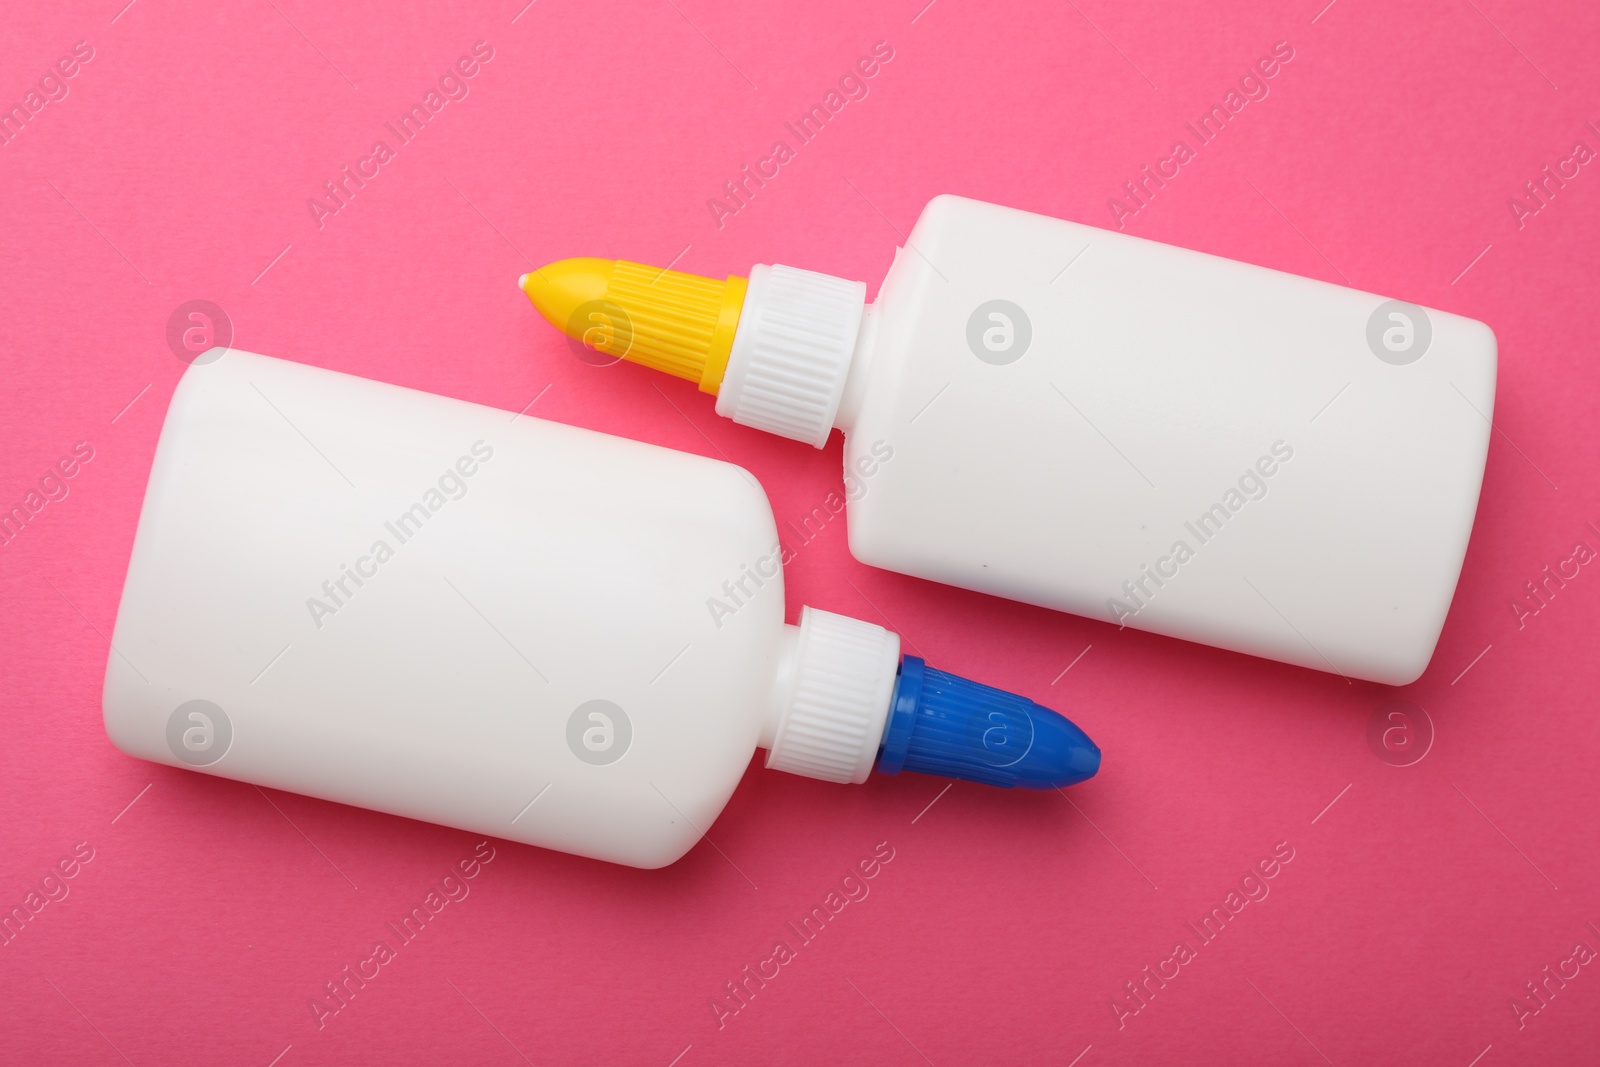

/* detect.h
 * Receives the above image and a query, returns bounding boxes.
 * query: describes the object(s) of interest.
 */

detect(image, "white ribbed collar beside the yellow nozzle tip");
[717,264,867,448]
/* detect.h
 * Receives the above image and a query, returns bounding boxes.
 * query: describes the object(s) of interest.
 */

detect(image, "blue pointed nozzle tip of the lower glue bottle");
[877,656,1101,789]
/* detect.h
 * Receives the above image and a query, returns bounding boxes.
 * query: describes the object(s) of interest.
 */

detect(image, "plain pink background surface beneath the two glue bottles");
[0,0,1600,1067]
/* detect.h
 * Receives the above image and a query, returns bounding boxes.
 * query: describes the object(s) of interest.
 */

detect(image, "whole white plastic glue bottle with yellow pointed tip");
[522,197,1496,685]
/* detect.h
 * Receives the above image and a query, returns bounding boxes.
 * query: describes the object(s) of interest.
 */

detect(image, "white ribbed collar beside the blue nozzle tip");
[763,608,899,782]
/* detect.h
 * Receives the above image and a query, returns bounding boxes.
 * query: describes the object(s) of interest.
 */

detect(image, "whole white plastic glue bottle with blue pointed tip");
[104,349,1099,867]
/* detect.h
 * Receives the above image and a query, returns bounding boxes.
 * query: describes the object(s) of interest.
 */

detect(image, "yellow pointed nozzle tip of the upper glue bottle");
[518,259,746,395]
